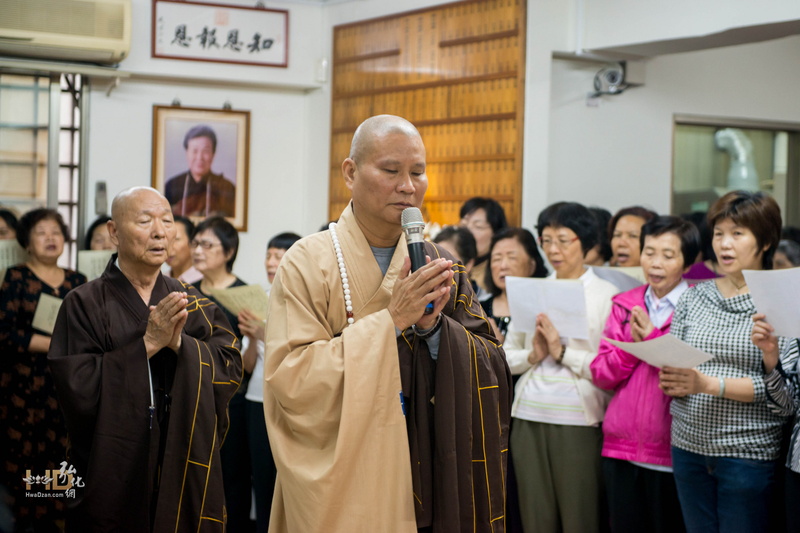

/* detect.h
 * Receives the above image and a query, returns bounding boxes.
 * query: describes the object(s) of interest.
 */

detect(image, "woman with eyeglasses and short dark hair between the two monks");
[191,217,252,531]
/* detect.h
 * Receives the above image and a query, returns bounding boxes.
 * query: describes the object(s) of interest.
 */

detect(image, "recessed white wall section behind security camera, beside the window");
[547,36,800,216]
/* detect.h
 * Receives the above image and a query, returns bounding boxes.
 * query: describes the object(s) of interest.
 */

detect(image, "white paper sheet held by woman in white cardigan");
[506,277,589,339]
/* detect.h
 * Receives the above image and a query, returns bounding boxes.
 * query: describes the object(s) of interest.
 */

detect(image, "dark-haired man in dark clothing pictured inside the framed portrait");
[164,124,236,218]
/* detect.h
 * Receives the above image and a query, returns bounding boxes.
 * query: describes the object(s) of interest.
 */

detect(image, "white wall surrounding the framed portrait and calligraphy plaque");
[91,1,329,283]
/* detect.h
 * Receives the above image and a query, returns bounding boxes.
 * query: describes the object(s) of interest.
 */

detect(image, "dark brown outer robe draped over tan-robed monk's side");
[397,242,512,533]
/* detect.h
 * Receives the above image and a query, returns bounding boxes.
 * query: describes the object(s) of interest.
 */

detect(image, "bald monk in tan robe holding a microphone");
[264,115,511,533]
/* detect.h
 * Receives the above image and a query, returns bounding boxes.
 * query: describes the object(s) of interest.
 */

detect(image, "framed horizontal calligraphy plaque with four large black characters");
[152,0,289,67]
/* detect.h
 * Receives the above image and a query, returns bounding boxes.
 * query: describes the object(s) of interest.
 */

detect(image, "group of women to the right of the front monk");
[456,191,800,533]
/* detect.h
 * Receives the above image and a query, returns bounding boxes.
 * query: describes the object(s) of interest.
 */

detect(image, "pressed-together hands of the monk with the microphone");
[388,257,453,330]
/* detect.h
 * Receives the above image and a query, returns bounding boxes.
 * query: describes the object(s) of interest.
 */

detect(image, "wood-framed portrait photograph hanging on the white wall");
[152,105,250,231]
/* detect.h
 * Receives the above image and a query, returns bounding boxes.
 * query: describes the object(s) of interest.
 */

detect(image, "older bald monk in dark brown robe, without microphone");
[48,187,242,533]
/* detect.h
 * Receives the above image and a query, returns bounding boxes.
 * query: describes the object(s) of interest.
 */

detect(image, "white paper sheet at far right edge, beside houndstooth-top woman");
[742,268,800,337]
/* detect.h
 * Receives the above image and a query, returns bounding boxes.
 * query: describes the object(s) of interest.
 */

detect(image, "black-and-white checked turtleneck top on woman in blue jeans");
[670,281,787,461]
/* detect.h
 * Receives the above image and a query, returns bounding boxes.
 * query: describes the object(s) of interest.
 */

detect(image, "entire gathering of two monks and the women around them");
[0,113,800,533]
